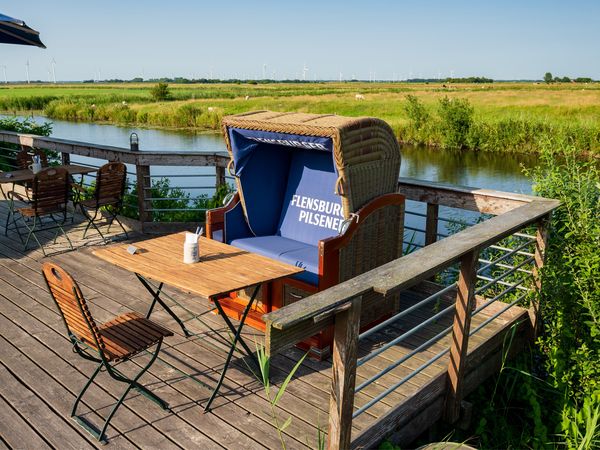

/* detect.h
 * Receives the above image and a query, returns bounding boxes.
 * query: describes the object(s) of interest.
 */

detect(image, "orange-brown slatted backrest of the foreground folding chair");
[42,262,105,349]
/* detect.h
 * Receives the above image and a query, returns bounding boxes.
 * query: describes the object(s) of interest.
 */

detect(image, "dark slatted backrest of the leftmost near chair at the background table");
[31,167,70,215]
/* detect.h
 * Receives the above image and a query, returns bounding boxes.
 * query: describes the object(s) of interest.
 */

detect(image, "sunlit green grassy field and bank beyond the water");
[0,82,600,154]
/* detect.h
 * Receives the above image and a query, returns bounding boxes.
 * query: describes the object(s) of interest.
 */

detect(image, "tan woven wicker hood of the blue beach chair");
[223,111,400,218]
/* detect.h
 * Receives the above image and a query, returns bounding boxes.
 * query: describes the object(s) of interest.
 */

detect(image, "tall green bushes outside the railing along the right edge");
[422,143,600,450]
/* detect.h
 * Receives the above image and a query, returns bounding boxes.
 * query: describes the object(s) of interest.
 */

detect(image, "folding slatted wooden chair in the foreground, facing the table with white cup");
[42,262,173,443]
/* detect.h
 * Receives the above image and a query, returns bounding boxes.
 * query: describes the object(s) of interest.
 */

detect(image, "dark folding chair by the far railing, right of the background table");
[73,162,129,242]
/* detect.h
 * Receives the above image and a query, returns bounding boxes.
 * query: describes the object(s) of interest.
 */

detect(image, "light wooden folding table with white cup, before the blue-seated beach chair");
[93,233,303,411]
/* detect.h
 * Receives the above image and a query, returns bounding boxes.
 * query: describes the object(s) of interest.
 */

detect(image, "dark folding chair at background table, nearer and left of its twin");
[12,167,73,256]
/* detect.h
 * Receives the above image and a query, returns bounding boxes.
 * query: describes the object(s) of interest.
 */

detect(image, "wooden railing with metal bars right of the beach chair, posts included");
[264,179,559,449]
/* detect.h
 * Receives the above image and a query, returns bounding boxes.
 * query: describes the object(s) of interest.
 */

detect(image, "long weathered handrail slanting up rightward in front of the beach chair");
[263,197,560,351]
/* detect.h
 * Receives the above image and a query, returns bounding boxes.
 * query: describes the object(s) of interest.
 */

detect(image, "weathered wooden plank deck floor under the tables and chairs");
[0,200,526,449]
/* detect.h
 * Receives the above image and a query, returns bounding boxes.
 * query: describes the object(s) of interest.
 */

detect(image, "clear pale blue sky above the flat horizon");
[0,0,600,81]
